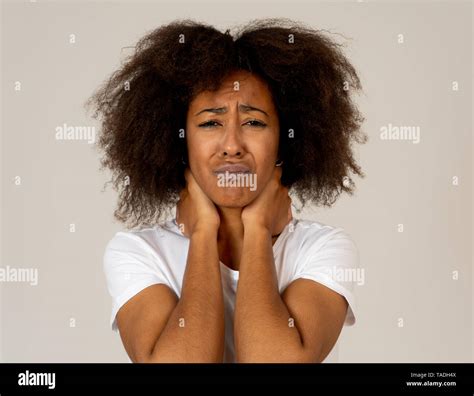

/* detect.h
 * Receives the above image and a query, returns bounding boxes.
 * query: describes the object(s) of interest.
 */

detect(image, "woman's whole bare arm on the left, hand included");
[117,172,224,362]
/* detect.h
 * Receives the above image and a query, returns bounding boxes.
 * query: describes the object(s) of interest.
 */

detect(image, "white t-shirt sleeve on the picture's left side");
[103,232,168,330]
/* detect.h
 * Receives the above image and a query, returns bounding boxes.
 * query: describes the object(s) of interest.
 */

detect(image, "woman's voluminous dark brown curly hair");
[88,19,367,226]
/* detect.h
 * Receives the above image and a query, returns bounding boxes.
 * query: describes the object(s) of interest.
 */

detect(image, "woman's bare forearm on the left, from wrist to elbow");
[146,227,224,362]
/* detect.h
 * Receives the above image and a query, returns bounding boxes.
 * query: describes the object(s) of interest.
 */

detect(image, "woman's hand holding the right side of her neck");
[242,167,292,235]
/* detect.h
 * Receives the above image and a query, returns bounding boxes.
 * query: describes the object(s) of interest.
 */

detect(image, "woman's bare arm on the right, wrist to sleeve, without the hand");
[234,225,347,363]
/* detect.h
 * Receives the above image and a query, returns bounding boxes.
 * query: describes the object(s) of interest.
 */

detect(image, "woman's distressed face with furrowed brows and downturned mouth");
[186,71,279,207]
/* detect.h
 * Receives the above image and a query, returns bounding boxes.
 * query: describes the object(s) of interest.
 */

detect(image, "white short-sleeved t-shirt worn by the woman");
[104,219,359,362]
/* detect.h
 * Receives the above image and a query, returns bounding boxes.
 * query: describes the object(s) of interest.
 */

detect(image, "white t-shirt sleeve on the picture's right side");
[294,228,363,326]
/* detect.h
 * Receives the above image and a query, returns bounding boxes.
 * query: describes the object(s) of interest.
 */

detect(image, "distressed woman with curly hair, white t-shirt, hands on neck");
[92,20,365,362]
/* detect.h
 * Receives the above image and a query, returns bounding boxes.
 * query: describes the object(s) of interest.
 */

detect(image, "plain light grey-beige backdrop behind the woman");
[0,1,474,362]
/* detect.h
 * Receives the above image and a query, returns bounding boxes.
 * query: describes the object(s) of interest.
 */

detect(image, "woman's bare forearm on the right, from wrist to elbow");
[234,226,302,362]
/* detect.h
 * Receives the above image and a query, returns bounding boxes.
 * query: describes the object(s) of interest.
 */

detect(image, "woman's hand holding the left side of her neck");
[176,168,220,238]
